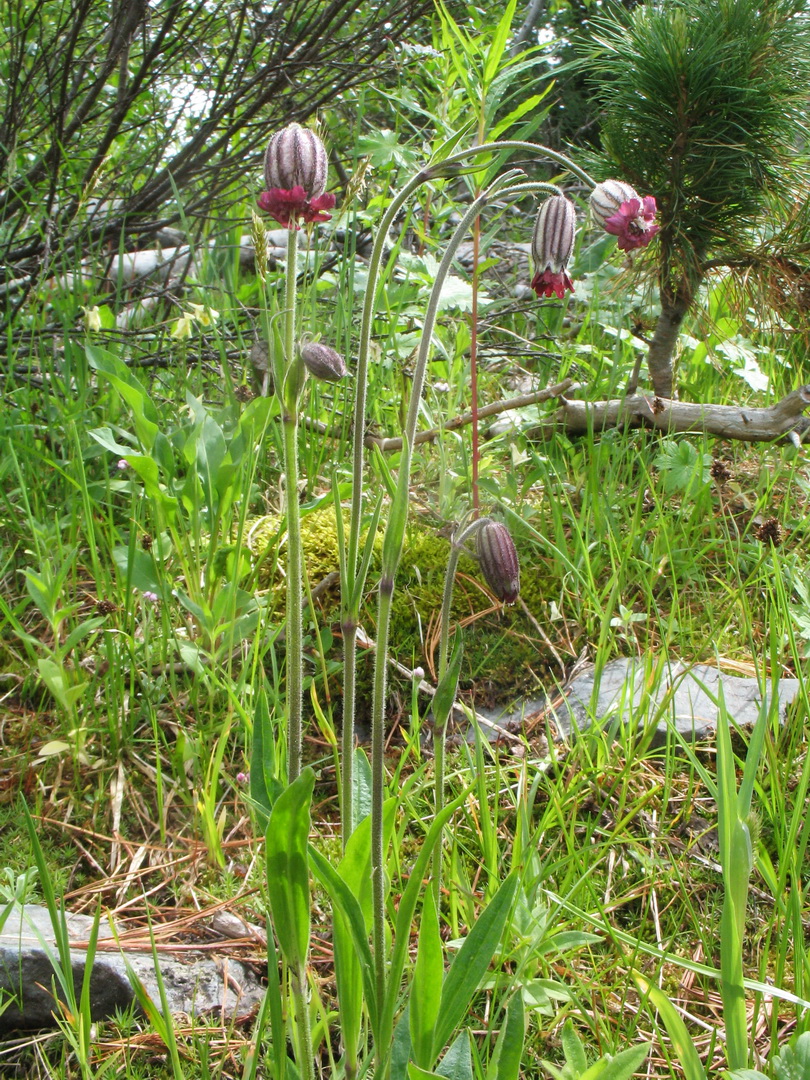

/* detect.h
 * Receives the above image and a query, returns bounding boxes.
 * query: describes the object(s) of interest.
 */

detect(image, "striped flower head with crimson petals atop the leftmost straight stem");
[258,124,335,229]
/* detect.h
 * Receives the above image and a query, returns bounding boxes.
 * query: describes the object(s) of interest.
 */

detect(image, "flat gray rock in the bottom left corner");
[0,904,264,1036]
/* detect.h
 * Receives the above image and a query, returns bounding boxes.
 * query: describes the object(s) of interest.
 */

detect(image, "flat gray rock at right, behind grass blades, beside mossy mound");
[481,658,800,743]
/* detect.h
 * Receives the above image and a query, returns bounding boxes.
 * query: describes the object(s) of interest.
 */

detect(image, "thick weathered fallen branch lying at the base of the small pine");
[526,386,810,446]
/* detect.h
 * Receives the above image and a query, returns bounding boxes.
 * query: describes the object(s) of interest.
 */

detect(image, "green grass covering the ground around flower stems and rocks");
[0,111,810,1078]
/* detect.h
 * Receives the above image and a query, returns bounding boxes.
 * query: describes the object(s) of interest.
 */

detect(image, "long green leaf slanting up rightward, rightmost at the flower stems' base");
[433,870,517,1059]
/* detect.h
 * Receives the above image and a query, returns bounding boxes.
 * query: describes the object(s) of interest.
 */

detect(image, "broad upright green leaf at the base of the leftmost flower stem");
[265,767,315,973]
